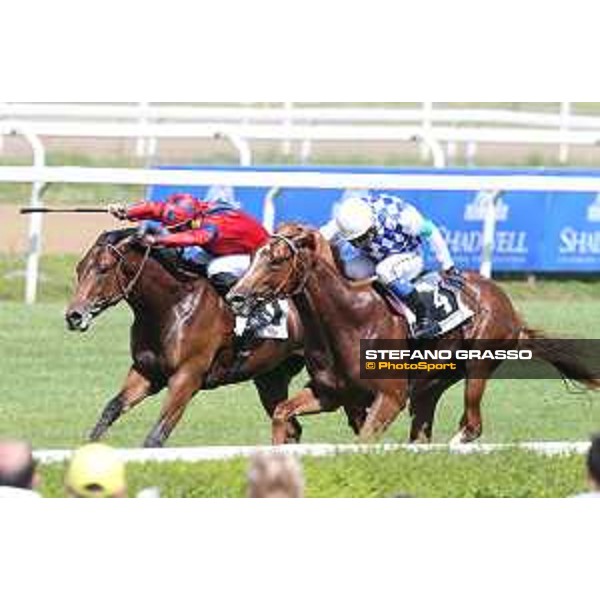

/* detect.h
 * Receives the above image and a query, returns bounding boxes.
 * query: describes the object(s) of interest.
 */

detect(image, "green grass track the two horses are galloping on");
[0,258,600,448]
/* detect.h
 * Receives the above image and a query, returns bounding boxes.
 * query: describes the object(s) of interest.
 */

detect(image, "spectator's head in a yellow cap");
[65,444,127,498]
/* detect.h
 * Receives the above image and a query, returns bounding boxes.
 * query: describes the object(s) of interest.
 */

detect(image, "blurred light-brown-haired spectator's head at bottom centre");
[248,454,304,498]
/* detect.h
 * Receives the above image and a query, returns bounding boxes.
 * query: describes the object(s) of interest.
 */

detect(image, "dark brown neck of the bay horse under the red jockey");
[128,258,203,322]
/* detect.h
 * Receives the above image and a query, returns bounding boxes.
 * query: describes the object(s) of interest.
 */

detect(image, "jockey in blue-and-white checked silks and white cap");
[321,194,458,339]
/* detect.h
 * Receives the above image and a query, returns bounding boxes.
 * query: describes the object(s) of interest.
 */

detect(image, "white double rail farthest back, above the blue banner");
[0,102,600,162]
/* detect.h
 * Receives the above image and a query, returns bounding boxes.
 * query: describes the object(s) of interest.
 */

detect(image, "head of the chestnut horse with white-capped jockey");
[227,225,333,316]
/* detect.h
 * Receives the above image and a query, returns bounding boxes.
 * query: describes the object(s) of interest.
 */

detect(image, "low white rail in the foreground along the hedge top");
[35,442,590,464]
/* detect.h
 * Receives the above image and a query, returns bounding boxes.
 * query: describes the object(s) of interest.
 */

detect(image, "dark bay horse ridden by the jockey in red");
[66,230,304,447]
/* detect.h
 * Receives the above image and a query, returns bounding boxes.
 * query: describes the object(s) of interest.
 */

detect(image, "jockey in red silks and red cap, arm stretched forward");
[108,194,269,292]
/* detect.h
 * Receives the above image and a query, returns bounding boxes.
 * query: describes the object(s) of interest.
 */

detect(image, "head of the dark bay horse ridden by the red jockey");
[66,230,144,332]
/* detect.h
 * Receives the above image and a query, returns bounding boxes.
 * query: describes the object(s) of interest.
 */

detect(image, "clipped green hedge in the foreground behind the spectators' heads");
[41,451,585,498]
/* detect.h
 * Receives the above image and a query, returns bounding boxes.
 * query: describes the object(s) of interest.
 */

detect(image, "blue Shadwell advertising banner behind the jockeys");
[150,167,600,273]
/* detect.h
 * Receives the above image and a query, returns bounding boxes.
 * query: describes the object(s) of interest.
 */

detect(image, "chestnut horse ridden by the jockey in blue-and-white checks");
[228,225,600,444]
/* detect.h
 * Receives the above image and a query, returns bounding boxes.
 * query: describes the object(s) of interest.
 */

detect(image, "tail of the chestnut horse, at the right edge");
[519,328,600,390]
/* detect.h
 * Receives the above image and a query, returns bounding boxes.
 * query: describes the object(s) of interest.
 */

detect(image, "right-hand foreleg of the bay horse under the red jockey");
[144,370,202,448]
